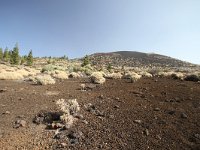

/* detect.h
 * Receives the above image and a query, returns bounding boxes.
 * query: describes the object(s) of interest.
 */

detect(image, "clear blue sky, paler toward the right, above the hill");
[0,0,200,64]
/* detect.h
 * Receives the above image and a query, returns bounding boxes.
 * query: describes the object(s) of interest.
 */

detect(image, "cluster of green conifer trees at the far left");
[0,44,33,66]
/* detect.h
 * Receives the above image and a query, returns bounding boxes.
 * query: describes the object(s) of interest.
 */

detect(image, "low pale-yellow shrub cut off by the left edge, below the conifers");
[0,71,24,80]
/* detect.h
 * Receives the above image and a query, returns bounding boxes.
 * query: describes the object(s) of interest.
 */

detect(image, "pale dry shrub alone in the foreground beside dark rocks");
[56,99,80,127]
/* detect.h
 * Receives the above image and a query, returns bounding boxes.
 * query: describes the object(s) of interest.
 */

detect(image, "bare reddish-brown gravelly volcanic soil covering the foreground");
[0,78,200,150]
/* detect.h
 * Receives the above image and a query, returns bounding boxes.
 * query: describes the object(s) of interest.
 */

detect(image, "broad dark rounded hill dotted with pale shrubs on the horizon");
[89,51,197,67]
